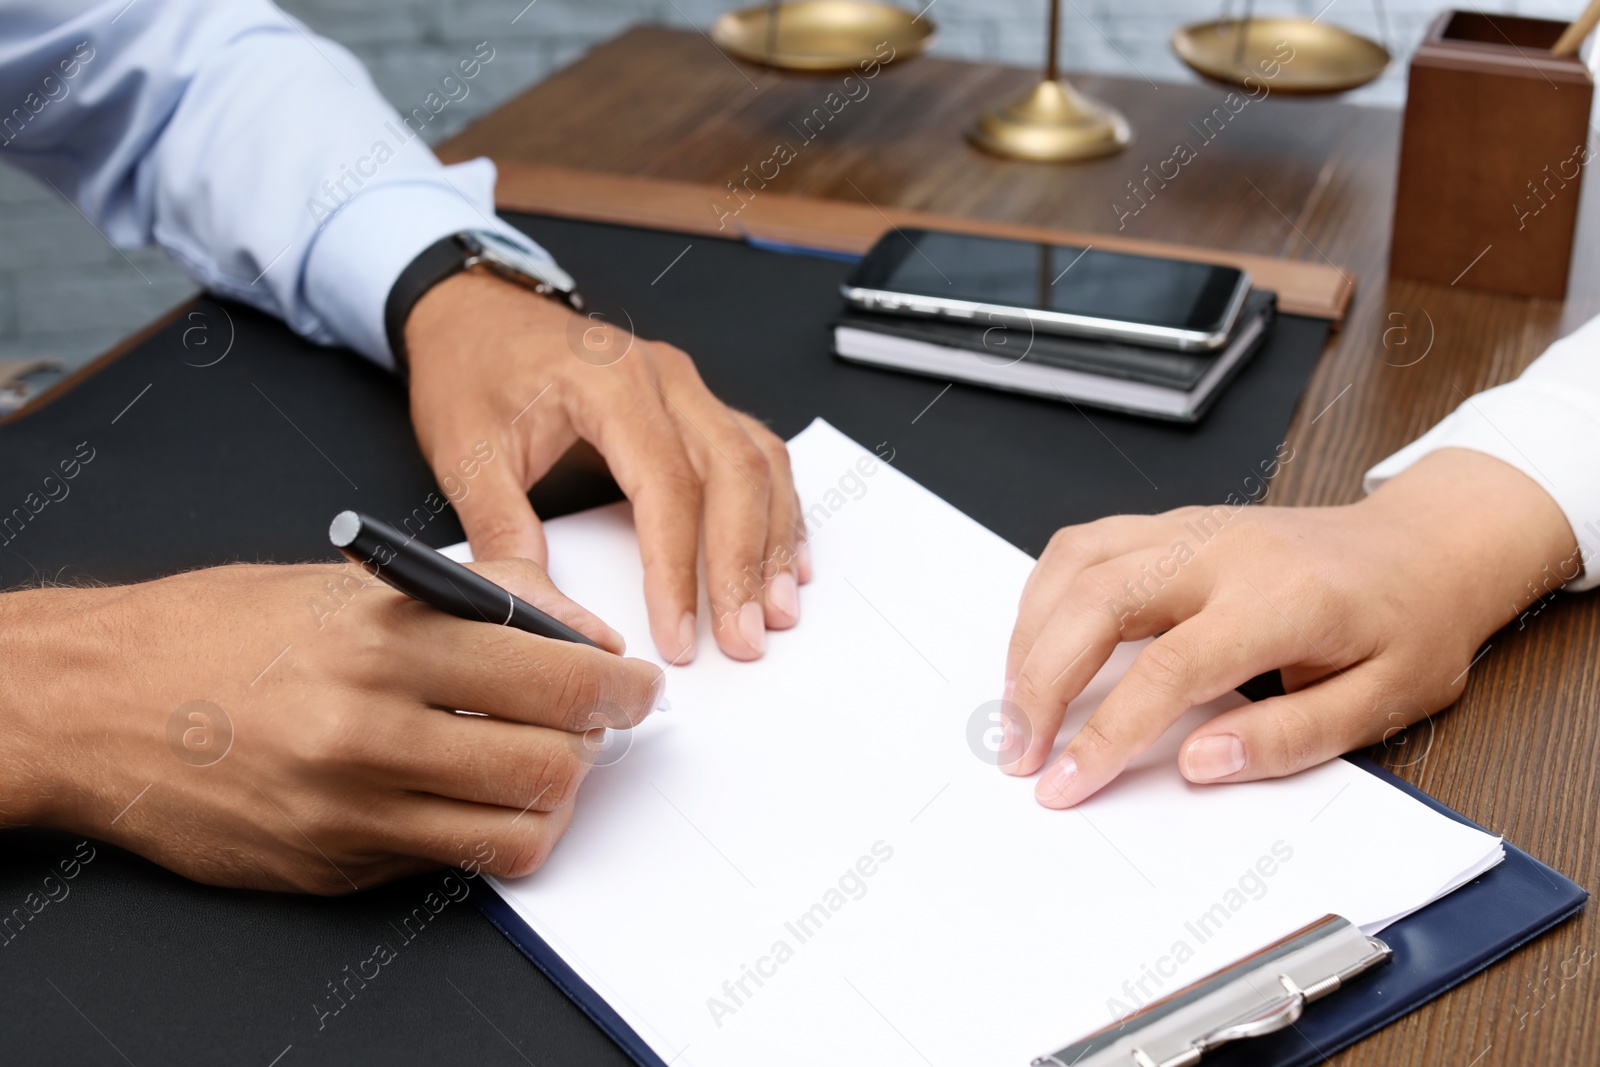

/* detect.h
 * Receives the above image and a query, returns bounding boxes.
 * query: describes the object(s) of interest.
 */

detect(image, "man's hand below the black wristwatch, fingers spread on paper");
[405,269,810,664]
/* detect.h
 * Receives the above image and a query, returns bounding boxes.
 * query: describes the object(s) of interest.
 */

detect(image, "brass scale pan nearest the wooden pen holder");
[1173,18,1389,96]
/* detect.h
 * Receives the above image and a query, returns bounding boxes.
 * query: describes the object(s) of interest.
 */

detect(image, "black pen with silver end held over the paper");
[328,512,600,648]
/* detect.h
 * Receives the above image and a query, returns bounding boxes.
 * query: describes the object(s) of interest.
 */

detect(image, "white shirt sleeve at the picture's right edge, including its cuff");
[1365,318,1600,592]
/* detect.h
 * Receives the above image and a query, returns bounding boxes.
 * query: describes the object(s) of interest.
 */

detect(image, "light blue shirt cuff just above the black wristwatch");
[302,158,554,370]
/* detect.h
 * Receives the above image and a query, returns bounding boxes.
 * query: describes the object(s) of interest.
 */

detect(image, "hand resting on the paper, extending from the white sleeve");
[1005,450,1581,808]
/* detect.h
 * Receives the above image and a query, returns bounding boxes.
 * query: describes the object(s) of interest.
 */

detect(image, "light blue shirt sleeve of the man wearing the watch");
[0,0,549,366]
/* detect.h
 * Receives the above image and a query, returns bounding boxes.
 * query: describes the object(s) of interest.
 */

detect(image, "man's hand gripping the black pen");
[0,560,664,894]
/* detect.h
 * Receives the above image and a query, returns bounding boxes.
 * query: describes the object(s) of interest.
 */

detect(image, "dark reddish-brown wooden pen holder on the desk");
[1389,11,1594,299]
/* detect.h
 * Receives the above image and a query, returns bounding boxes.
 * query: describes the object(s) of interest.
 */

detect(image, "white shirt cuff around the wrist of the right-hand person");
[1362,376,1600,592]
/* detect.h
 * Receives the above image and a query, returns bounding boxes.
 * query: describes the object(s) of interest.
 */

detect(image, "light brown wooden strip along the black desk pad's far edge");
[494,160,1355,323]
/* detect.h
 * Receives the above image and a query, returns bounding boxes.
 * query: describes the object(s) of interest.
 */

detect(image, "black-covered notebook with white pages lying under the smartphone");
[834,290,1277,422]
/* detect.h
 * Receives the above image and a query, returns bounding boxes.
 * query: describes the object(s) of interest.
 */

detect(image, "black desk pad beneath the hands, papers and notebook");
[0,218,1326,1067]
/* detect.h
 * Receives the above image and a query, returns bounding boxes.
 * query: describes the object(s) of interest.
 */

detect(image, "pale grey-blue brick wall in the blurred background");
[0,0,1582,365]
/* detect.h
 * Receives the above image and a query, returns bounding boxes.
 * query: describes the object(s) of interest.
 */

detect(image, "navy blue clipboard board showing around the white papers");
[470,755,1589,1067]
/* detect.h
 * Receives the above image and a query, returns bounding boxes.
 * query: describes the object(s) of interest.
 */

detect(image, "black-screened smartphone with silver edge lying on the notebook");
[840,229,1250,352]
